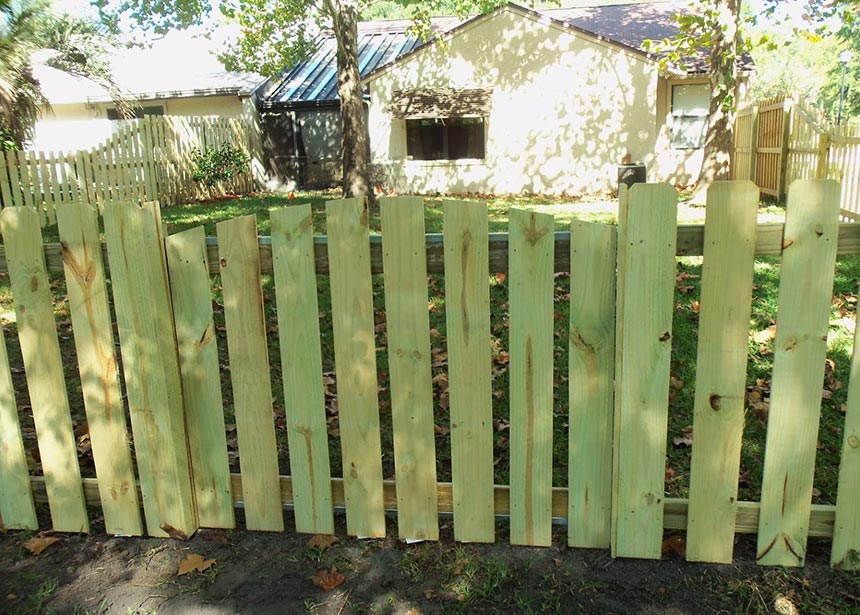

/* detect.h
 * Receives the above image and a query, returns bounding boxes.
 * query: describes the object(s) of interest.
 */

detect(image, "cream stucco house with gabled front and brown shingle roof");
[263,0,750,194]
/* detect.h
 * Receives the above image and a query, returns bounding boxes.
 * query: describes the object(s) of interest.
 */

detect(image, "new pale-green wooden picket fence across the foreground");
[0,180,860,568]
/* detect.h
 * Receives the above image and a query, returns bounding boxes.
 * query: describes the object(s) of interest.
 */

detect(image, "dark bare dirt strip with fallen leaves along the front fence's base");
[0,518,860,615]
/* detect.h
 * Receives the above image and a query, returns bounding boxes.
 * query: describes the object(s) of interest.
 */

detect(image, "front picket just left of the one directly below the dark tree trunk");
[270,205,334,534]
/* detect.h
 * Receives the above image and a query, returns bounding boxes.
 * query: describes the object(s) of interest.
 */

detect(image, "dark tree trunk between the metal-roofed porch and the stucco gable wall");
[329,0,370,197]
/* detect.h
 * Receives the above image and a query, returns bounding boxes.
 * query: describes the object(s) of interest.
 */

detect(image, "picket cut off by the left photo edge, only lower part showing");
[0,331,39,530]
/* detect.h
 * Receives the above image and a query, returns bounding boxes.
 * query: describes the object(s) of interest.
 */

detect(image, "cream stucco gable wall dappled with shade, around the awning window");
[369,9,664,193]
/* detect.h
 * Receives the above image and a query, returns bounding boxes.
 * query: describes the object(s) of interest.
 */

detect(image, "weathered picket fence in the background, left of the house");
[0,116,253,225]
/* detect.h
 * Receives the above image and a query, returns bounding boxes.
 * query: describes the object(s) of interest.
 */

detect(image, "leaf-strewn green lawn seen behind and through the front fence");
[0,192,860,510]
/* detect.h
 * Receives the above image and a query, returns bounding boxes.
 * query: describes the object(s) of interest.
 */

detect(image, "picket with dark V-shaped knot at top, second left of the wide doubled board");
[508,209,555,546]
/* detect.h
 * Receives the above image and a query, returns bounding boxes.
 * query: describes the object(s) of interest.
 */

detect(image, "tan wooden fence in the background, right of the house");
[732,96,860,221]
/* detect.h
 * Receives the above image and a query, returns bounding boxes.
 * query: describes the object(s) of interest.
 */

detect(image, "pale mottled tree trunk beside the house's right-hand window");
[691,0,741,203]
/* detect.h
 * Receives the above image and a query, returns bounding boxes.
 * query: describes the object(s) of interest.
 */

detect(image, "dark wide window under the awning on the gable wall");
[406,117,485,160]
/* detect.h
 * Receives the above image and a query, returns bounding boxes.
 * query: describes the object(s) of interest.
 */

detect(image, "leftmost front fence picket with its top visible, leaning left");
[0,207,89,532]
